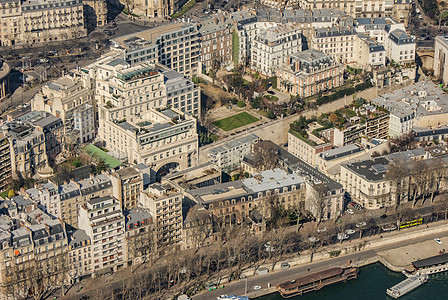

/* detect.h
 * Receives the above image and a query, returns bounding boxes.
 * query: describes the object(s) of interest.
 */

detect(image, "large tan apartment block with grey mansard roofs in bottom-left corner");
[0,196,69,299]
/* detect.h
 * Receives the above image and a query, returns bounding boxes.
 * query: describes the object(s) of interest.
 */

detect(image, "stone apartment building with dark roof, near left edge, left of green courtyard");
[2,121,48,178]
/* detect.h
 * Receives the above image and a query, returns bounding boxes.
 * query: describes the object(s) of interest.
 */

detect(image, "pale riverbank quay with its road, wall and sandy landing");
[193,221,448,300]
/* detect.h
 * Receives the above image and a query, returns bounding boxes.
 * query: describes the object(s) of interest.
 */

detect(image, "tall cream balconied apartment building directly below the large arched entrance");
[140,183,183,247]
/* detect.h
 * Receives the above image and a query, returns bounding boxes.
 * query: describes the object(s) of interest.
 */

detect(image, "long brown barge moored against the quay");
[278,267,358,298]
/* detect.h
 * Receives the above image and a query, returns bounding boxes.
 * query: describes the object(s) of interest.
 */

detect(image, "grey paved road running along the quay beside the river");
[193,227,448,300]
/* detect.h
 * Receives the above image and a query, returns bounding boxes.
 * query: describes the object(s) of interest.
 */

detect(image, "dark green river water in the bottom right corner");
[257,263,448,300]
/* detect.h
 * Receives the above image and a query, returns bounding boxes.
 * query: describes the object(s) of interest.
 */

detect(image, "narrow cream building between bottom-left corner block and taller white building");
[67,229,93,283]
